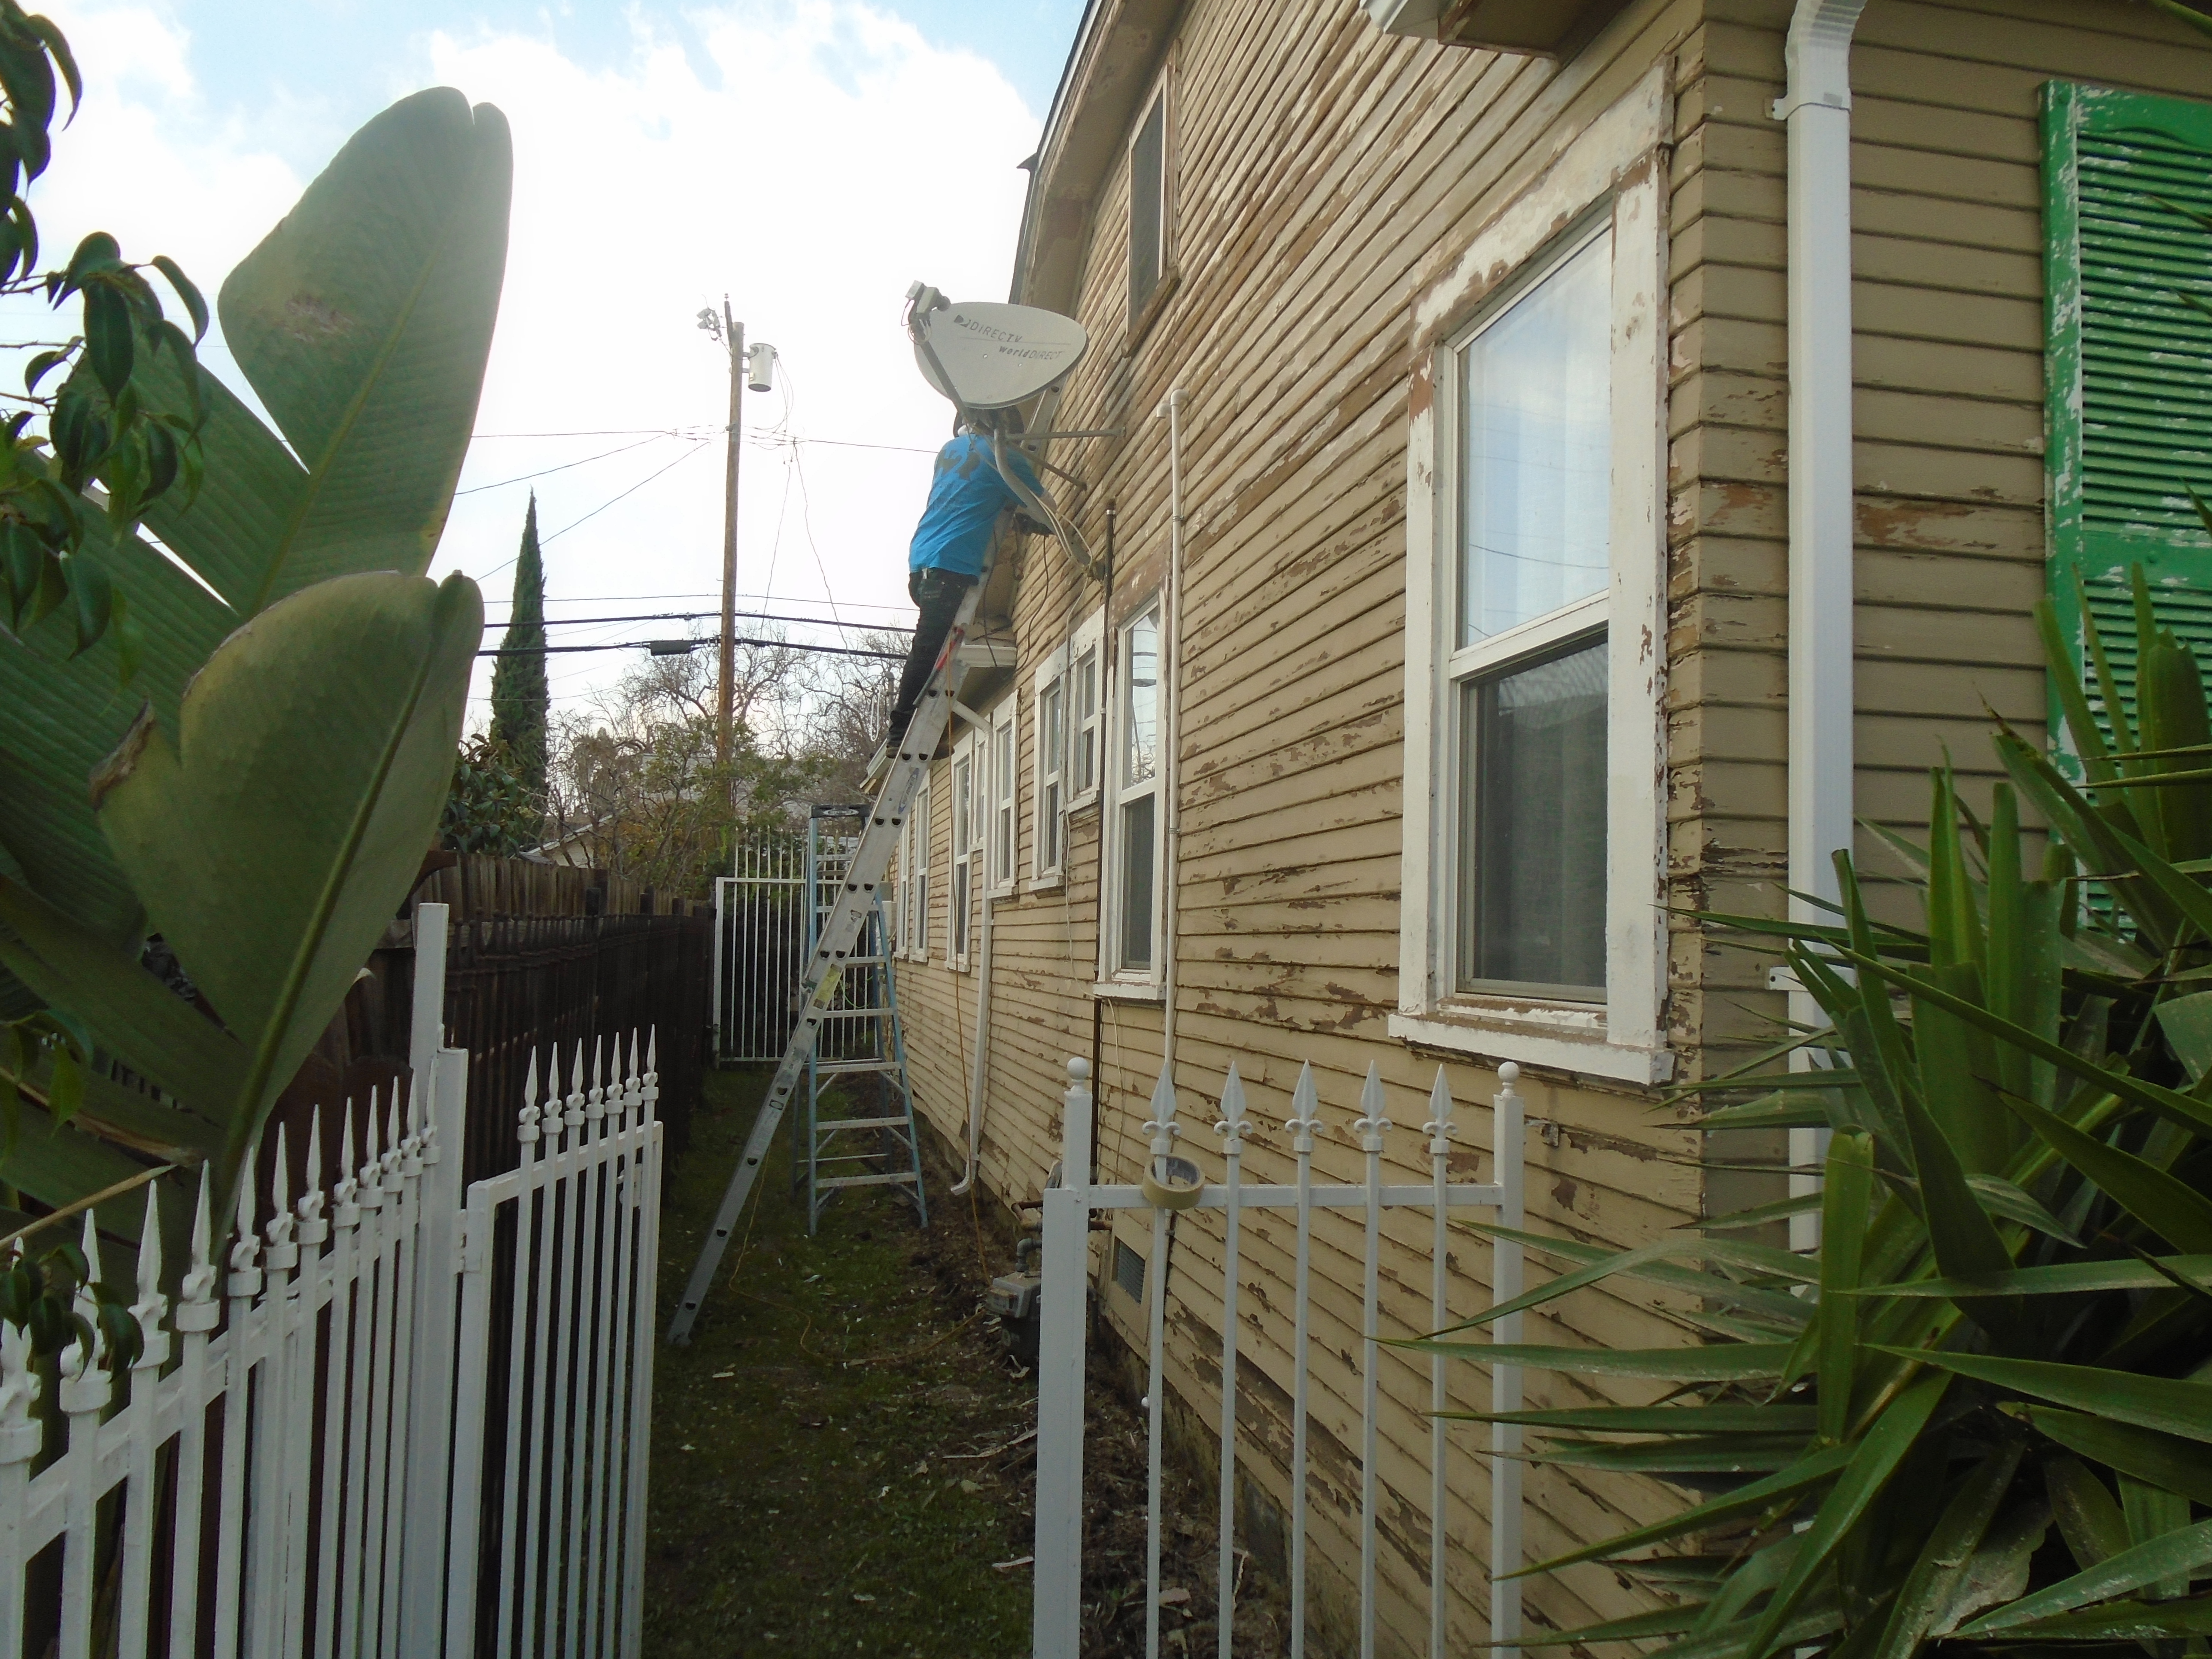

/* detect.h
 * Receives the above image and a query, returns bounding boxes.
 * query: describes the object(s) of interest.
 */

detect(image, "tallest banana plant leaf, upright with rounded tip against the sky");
[0,88,513,1053]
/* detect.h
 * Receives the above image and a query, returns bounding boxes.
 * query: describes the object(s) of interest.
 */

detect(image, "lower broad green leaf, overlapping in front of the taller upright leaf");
[11,573,484,1206]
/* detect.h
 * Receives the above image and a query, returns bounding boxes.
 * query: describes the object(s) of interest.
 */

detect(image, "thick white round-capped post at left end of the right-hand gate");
[1033,1060,1093,1659]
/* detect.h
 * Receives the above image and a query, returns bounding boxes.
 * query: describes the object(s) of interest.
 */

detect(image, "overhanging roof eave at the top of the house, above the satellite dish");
[1009,0,1183,312]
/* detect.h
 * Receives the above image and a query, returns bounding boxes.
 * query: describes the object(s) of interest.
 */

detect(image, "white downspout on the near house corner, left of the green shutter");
[1774,0,1867,1250]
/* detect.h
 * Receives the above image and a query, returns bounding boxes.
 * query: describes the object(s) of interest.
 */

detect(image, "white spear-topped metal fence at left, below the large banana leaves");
[0,905,661,1659]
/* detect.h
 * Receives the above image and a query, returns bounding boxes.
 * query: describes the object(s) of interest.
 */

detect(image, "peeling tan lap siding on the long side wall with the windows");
[960,0,1734,1641]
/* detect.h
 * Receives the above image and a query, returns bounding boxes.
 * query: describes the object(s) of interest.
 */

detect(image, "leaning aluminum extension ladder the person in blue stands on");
[668,566,991,1343]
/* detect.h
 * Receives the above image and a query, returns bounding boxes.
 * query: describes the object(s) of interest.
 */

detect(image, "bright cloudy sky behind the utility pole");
[15,0,1082,726]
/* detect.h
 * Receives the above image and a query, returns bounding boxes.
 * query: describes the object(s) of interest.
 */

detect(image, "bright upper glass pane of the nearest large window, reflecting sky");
[1460,230,1613,646]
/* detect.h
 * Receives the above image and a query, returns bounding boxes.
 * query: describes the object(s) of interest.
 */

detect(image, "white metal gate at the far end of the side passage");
[714,825,807,1064]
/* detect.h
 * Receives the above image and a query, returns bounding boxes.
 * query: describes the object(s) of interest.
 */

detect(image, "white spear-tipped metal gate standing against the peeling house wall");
[1033,1060,1524,1659]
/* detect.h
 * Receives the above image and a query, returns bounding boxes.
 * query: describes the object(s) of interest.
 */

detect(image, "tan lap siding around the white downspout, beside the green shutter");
[1672,0,2212,942]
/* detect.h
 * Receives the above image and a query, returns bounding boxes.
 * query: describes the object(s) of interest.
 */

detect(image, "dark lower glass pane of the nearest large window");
[1458,639,1606,993]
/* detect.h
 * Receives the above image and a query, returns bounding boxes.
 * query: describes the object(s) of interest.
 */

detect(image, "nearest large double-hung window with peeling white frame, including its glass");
[1389,73,1672,1084]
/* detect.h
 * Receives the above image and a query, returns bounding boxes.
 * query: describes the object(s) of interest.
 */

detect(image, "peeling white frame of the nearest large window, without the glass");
[1389,64,1674,1084]
